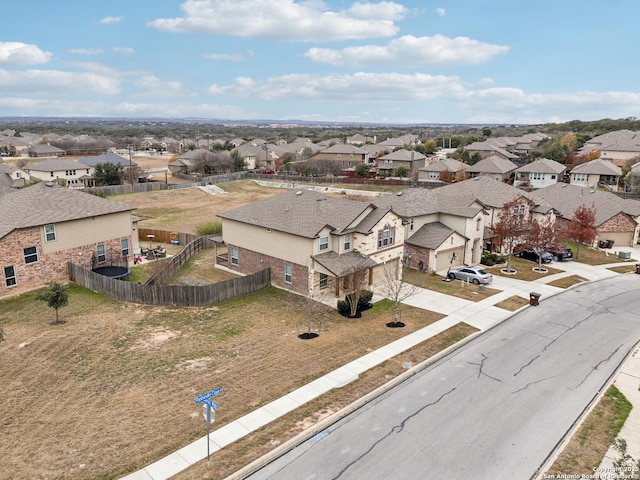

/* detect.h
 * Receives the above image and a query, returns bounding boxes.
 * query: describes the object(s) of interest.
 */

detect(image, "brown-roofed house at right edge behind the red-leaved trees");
[530,183,640,247]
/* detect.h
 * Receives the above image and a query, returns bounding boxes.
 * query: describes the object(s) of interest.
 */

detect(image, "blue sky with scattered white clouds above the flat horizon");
[0,0,640,124]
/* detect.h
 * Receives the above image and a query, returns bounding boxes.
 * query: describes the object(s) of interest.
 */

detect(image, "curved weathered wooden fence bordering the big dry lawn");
[67,262,271,307]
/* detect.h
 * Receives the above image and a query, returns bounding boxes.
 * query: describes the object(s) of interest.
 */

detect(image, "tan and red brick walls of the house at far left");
[0,227,133,298]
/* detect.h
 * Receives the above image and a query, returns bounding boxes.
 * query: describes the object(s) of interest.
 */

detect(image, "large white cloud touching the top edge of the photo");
[148,0,407,41]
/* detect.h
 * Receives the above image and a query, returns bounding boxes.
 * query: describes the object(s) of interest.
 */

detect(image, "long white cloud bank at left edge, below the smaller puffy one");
[0,70,120,95]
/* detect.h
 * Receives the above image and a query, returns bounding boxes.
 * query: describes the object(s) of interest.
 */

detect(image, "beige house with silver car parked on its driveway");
[373,188,487,272]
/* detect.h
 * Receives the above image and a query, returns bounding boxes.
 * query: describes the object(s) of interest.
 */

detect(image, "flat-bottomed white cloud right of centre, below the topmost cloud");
[305,35,509,67]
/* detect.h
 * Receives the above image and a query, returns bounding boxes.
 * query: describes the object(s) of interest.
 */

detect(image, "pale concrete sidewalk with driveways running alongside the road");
[123,253,640,480]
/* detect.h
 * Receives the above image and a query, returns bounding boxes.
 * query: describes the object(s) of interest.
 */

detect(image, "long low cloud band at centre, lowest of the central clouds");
[209,72,463,104]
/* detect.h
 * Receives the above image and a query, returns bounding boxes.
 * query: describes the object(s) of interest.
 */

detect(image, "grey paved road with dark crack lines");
[249,275,640,480]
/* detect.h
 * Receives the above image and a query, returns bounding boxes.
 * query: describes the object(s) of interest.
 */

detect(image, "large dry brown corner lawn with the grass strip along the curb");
[0,285,474,479]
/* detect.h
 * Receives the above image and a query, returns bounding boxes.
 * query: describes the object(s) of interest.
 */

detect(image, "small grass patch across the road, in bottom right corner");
[546,385,632,478]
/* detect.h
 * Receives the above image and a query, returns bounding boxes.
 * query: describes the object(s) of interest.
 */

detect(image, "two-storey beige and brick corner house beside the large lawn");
[218,190,405,297]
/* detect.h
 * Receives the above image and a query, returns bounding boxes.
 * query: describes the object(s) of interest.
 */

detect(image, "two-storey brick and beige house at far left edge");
[0,182,135,297]
